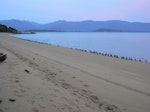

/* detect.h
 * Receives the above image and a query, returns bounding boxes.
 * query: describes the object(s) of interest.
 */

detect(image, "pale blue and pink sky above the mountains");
[0,0,150,23]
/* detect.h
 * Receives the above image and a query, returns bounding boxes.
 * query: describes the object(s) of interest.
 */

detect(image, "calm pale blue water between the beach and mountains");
[13,32,150,61]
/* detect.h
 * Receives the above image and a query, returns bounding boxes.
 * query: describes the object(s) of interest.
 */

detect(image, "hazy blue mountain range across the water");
[0,19,150,32]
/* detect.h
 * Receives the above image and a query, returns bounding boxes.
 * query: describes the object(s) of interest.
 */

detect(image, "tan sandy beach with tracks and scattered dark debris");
[0,33,150,112]
